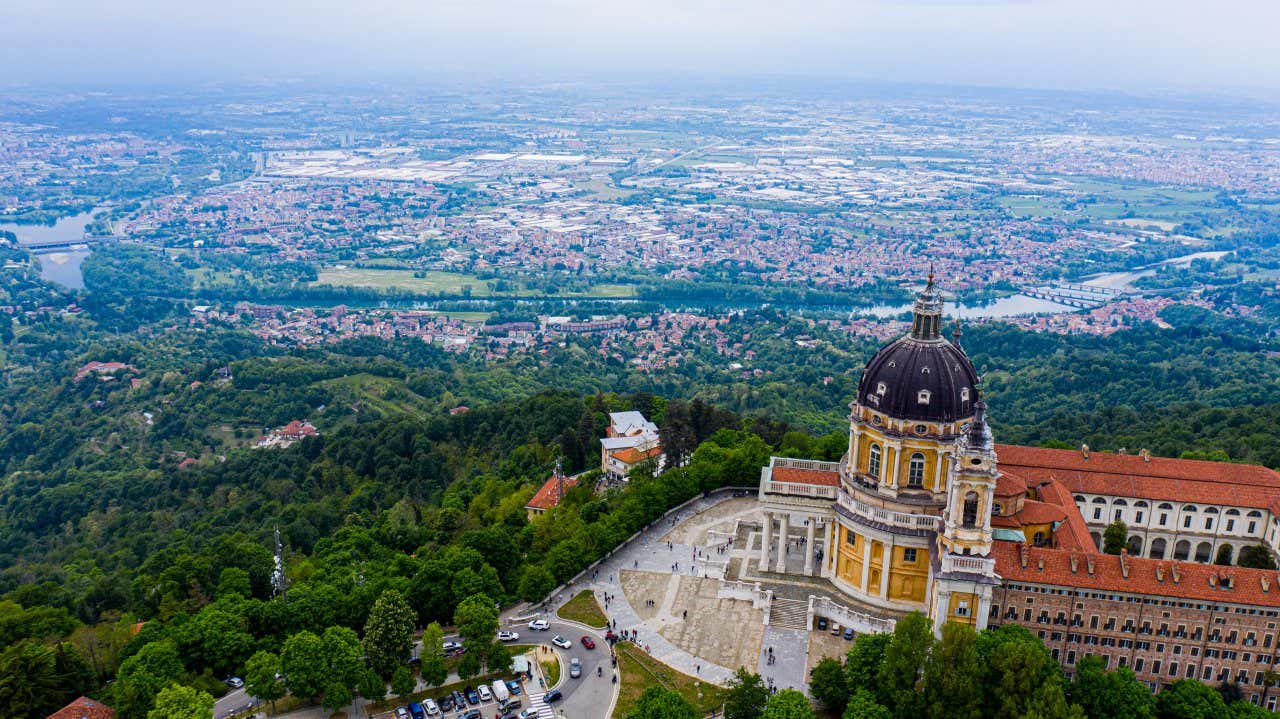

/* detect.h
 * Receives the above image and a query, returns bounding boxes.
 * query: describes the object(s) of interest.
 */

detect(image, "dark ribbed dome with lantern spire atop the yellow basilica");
[858,273,979,422]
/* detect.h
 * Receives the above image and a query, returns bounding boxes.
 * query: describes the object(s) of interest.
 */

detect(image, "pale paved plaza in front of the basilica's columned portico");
[552,493,870,691]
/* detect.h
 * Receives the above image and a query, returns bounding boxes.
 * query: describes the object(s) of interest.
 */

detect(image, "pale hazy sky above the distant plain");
[0,0,1280,95]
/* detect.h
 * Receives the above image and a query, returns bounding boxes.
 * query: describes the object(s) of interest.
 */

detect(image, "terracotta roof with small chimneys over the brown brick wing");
[991,541,1280,608]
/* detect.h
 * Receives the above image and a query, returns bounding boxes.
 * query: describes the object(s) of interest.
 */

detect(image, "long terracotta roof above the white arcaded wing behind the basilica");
[996,444,1280,513]
